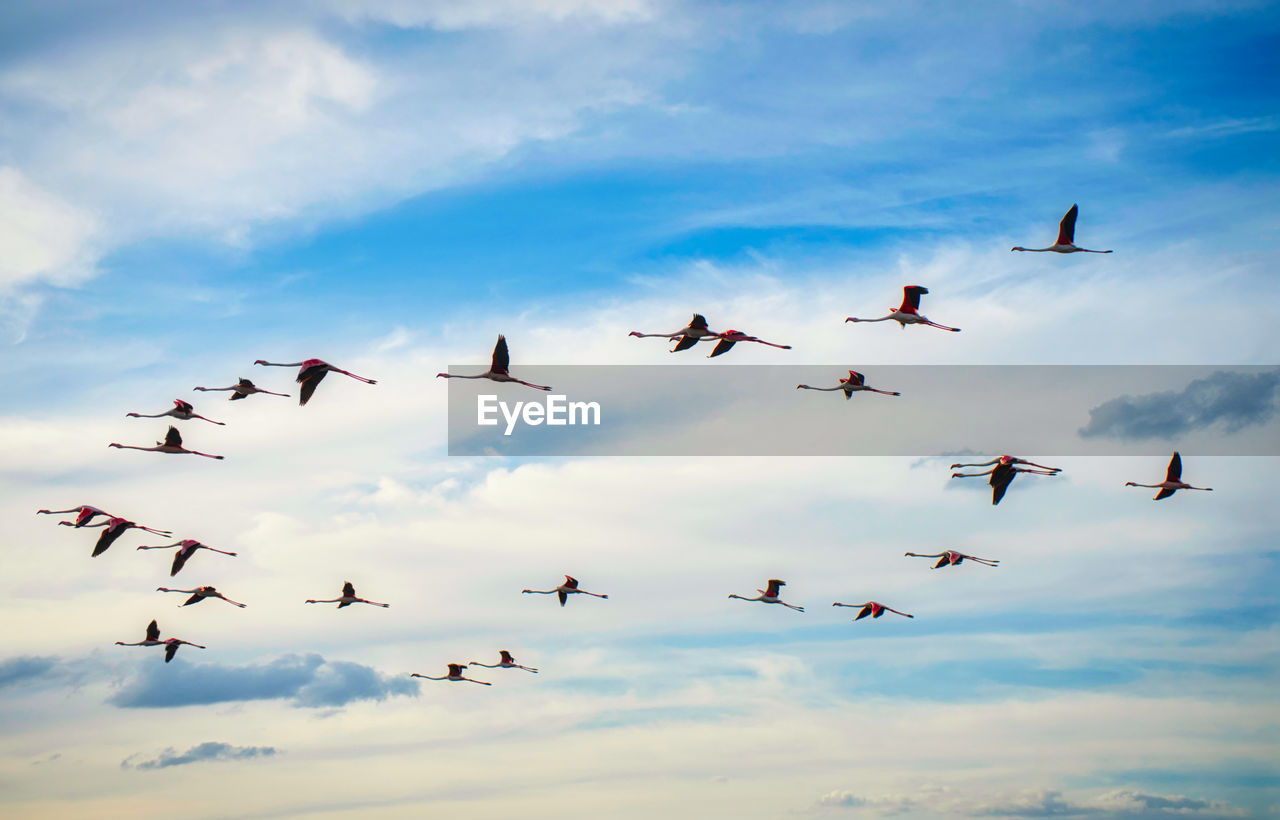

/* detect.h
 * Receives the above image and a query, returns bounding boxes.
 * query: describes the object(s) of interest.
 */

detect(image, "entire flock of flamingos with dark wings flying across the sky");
[30,205,1212,686]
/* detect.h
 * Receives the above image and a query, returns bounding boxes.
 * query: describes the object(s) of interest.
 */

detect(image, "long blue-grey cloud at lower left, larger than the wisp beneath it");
[109,652,417,709]
